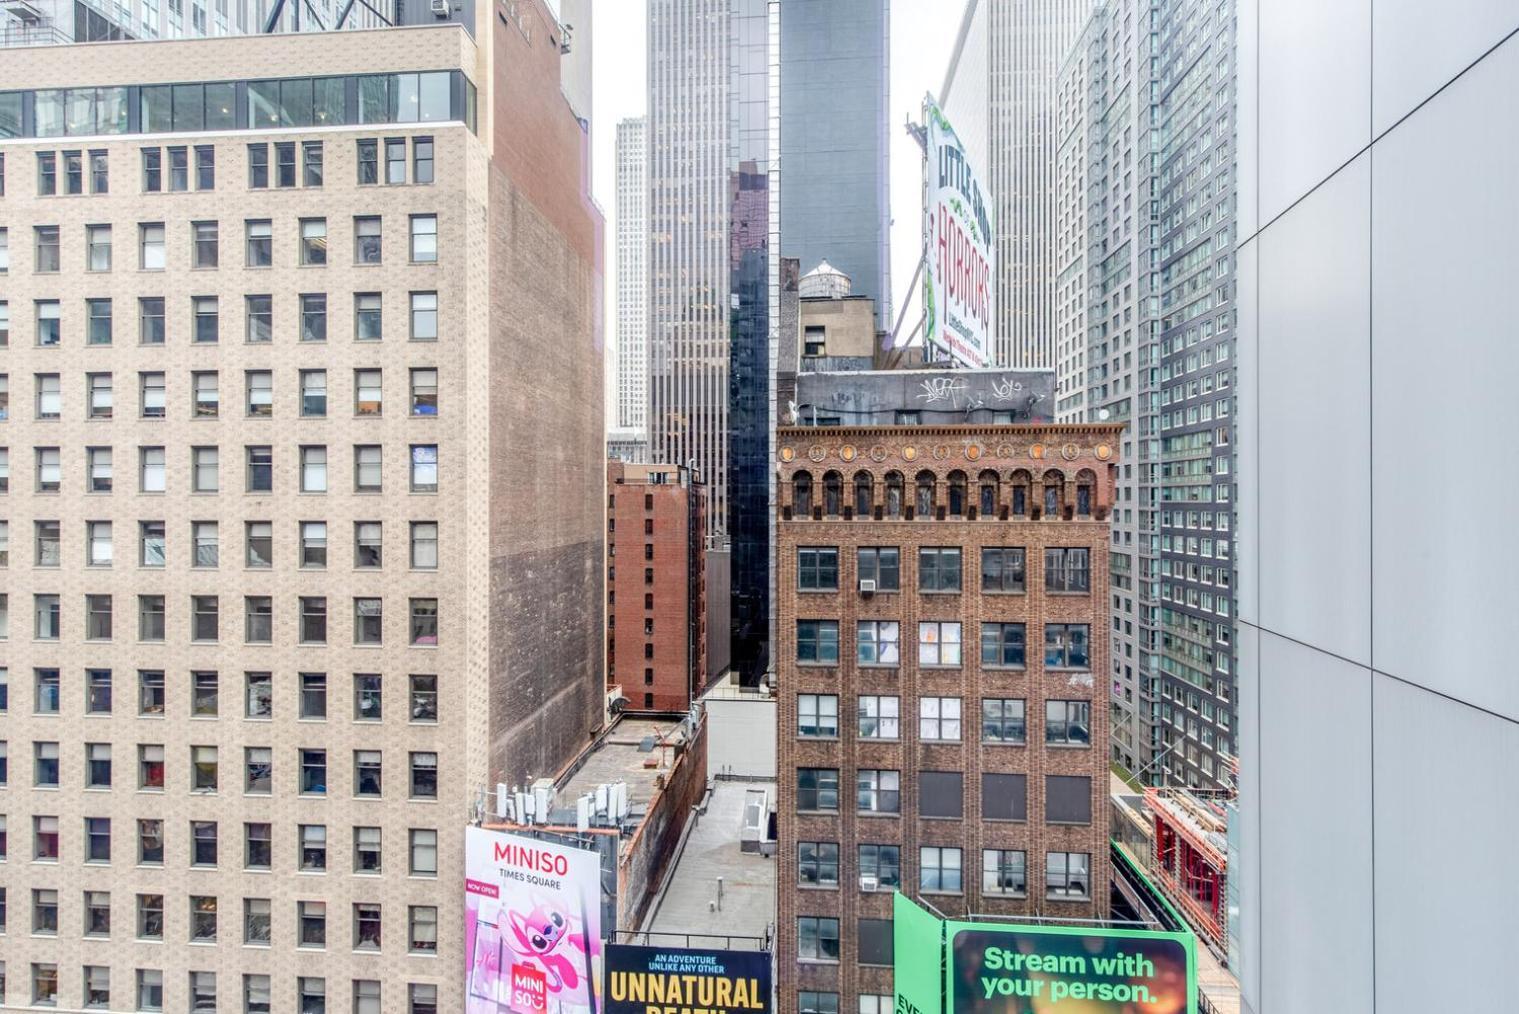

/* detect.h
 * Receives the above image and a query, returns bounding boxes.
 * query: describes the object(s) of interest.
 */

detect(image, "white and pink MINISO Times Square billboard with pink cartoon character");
[465,827,602,1014]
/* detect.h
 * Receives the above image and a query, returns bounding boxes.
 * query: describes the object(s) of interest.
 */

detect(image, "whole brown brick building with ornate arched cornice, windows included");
[775,424,1121,1014]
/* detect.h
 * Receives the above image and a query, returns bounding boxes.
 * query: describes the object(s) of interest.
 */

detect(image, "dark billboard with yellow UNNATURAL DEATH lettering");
[605,944,770,1014]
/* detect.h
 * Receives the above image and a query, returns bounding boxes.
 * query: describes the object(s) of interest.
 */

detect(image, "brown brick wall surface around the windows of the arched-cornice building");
[775,427,1118,1011]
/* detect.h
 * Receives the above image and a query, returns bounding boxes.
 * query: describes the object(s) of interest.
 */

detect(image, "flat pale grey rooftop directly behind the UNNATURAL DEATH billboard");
[636,780,776,947]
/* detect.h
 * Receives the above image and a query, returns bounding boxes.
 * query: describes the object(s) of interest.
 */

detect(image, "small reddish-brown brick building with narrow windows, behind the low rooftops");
[606,461,706,712]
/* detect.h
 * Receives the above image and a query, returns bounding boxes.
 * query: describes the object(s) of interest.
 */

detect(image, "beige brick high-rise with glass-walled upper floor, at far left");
[0,3,605,1014]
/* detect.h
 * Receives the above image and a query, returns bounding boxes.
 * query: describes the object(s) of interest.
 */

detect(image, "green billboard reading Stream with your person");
[893,894,1197,1014]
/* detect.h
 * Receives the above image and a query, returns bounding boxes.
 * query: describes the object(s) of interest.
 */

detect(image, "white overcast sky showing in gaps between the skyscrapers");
[591,0,965,384]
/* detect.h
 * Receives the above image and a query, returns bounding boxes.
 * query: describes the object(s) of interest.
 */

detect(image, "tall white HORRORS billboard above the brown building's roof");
[924,96,996,369]
